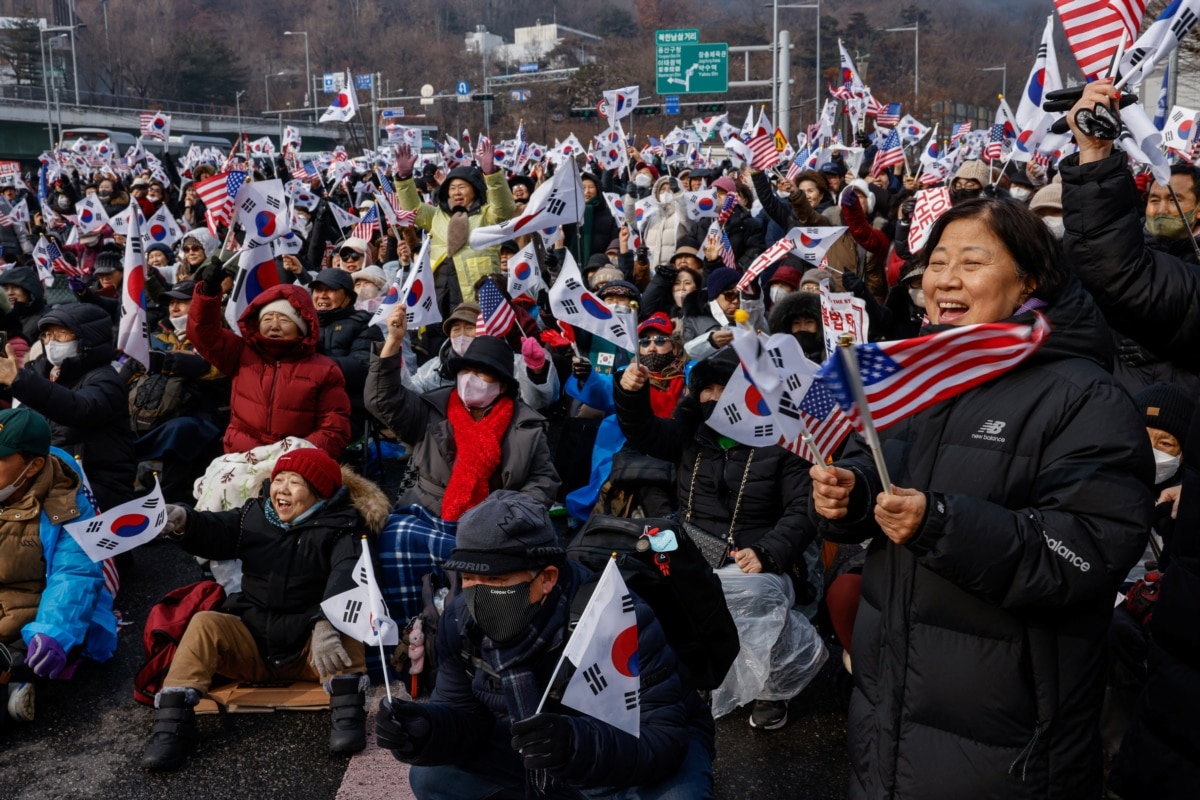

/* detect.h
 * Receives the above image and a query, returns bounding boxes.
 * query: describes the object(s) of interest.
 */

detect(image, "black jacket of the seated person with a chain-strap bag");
[613,379,816,572]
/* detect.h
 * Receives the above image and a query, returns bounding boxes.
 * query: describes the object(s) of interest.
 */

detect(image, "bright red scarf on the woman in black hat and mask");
[442,392,514,522]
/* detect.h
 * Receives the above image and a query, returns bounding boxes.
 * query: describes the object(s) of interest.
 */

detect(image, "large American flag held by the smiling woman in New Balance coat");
[817,314,1050,433]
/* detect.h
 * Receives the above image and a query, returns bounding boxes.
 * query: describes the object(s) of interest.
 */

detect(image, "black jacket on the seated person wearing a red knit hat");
[179,481,367,666]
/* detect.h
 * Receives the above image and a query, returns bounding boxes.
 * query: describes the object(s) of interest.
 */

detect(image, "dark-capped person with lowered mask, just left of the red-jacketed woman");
[130,281,229,503]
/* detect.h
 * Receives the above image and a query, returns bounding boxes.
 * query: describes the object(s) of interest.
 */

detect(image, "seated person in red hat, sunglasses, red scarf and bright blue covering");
[566,312,684,522]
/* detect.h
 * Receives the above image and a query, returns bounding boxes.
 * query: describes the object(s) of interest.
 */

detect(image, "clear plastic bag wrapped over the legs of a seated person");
[713,565,829,717]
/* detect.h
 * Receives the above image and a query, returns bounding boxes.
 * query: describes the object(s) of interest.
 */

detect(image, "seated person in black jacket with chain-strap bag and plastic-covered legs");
[613,348,824,730]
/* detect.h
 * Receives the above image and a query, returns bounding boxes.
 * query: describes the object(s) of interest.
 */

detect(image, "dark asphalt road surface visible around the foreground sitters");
[0,494,848,800]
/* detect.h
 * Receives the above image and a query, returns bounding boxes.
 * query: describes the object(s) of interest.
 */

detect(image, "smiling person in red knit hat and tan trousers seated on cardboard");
[142,447,388,771]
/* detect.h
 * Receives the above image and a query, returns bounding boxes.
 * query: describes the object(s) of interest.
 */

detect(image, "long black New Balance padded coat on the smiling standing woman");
[821,281,1153,800]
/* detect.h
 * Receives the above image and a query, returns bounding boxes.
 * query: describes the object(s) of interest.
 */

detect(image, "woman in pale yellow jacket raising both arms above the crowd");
[396,139,517,317]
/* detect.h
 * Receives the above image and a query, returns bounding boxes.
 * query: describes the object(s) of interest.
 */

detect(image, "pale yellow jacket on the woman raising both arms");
[396,169,517,302]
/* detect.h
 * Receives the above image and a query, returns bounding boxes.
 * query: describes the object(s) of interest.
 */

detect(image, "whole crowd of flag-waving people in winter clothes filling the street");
[0,82,1200,798]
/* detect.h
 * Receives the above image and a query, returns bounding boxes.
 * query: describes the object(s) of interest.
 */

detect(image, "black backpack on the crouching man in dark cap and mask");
[566,515,740,690]
